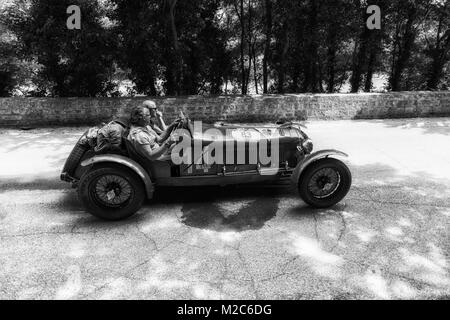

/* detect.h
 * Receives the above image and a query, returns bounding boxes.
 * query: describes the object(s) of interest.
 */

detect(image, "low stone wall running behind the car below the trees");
[0,91,450,126]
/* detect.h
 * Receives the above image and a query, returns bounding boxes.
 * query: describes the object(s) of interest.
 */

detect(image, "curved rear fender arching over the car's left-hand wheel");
[81,154,155,199]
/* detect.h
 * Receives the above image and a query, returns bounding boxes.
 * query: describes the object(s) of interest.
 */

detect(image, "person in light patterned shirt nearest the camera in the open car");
[127,104,179,160]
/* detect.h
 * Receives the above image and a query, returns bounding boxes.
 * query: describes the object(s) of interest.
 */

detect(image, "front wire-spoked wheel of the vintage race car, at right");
[298,158,352,208]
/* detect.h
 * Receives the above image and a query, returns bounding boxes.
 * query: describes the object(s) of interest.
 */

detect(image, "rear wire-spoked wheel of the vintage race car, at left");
[78,166,146,221]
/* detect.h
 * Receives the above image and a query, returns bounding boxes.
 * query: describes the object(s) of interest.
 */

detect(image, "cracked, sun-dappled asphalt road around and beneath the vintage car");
[0,118,450,299]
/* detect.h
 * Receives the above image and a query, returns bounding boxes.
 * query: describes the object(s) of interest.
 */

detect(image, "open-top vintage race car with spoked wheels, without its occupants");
[61,118,352,220]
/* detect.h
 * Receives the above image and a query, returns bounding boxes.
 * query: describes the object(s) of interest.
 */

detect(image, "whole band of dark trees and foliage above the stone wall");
[0,0,450,96]
